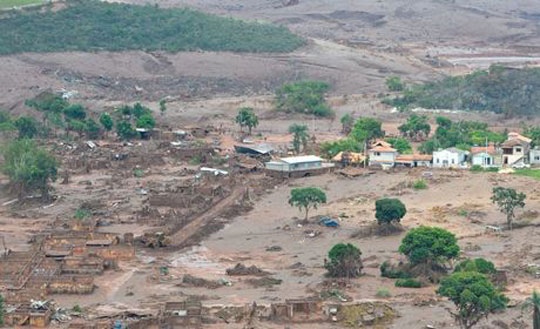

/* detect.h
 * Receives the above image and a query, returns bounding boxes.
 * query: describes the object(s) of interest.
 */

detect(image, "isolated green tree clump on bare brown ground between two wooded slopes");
[275,81,333,117]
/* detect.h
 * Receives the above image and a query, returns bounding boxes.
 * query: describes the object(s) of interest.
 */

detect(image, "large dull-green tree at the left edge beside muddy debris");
[2,139,58,200]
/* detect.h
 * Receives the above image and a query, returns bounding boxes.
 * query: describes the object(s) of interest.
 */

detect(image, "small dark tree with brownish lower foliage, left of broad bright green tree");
[324,243,363,279]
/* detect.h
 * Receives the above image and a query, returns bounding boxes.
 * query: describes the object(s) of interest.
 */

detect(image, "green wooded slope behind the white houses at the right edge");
[386,66,540,117]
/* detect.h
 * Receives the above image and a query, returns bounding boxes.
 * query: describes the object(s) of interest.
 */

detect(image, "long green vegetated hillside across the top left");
[0,0,304,54]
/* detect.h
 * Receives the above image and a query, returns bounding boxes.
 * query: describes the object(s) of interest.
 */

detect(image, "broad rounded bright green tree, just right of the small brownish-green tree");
[399,226,459,268]
